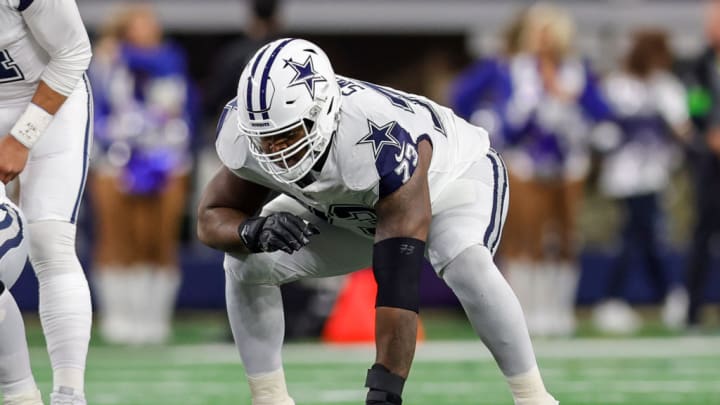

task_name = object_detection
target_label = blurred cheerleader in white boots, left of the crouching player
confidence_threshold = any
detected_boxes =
[90,5,191,344]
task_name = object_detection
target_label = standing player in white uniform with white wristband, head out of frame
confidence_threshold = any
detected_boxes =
[0,0,92,405]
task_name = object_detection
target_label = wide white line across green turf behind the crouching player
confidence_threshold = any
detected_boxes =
[31,337,720,368]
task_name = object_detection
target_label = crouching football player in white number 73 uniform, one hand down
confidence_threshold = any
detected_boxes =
[198,38,557,405]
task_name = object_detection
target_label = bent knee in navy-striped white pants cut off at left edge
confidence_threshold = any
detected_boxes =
[0,182,28,289]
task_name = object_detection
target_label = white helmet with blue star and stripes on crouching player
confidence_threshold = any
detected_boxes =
[237,38,340,183]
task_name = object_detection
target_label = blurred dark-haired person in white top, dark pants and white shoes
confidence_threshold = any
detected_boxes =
[593,30,691,333]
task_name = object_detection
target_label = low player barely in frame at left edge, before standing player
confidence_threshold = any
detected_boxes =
[0,182,43,405]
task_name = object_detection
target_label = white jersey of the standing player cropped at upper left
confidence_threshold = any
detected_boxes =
[0,0,90,107]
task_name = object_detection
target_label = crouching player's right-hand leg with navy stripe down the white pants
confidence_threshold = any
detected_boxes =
[428,150,557,405]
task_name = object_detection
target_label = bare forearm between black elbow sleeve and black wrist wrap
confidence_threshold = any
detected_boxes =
[375,307,418,378]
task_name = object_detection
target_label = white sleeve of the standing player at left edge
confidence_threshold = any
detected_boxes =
[10,0,92,96]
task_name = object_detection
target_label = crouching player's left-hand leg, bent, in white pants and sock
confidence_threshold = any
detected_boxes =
[224,196,372,405]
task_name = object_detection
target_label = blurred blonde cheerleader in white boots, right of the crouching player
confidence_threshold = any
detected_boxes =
[502,3,611,336]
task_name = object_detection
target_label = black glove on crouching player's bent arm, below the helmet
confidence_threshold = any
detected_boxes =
[238,212,320,254]
